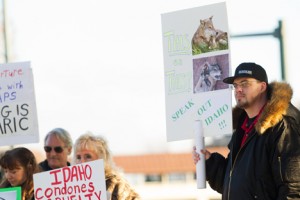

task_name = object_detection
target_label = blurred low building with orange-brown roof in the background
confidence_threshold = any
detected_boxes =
[114,147,228,200]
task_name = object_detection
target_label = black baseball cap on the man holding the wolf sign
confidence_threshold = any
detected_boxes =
[223,62,268,84]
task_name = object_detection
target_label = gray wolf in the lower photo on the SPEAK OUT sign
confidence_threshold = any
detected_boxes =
[194,62,222,93]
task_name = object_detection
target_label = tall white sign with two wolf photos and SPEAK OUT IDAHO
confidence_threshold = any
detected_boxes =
[161,2,232,141]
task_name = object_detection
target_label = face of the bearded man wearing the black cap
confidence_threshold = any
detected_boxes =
[233,78,266,109]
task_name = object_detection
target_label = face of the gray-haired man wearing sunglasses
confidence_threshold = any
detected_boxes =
[45,135,72,169]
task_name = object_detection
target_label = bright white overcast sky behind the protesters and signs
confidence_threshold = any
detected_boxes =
[1,0,300,155]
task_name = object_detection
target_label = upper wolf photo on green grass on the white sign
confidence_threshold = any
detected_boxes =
[192,16,228,55]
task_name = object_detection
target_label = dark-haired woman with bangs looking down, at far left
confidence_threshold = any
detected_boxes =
[0,147,40,200]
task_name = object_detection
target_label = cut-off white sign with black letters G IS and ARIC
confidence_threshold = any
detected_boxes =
[0,62,39,146]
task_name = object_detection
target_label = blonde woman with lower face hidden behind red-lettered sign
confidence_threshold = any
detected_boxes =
[73,132,140,200]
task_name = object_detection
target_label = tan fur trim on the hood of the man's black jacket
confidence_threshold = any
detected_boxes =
[233,82,293,134]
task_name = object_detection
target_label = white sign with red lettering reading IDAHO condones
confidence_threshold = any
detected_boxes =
[33,159,107,200]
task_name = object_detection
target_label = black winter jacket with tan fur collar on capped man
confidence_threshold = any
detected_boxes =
[206,82,300,200]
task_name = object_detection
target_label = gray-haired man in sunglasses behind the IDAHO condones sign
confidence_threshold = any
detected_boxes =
[39,128,73,171]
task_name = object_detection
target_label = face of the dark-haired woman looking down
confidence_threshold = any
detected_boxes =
[4,166,26,187]
